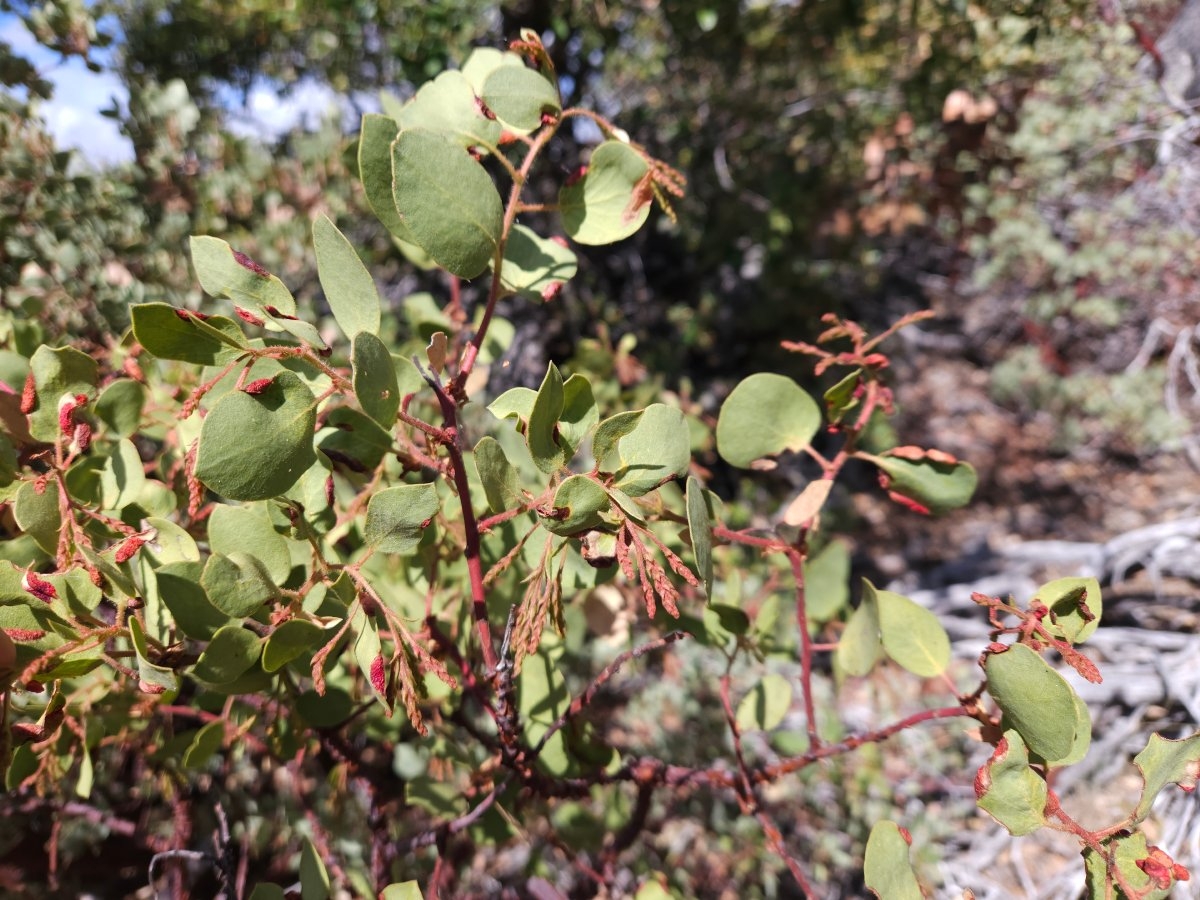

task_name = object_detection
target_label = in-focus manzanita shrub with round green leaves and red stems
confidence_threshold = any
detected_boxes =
[0,34,1200,900]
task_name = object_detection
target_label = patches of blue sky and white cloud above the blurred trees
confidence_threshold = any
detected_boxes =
[0,14,344,167]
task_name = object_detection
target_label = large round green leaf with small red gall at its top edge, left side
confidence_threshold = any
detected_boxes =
[196,372,317,500]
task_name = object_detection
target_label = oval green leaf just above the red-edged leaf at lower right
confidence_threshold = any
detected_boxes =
[984,644,1075,760]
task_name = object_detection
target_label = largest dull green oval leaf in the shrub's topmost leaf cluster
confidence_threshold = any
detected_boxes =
[391,130,504,278]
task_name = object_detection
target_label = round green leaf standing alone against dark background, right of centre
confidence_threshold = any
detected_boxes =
[716,372,821,469]
